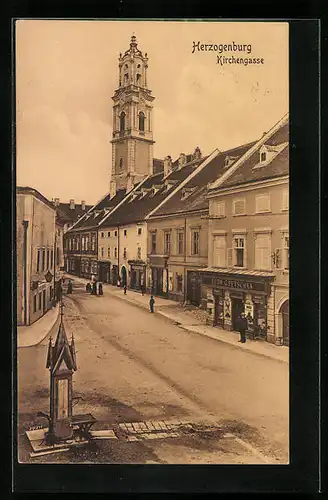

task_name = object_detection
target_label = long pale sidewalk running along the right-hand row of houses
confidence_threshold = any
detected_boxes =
[67,275,289,363]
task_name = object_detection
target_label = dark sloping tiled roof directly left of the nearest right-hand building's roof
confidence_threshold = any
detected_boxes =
[153,142,255,217]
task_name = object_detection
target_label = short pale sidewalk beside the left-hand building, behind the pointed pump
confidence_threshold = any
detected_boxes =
[17,304,59,347]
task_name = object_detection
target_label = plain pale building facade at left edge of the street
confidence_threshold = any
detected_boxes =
[16,187,57,326]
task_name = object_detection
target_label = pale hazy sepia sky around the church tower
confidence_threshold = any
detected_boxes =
[16,20,289,204]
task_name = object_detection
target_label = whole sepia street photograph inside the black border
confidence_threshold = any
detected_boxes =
[14,19,290,465]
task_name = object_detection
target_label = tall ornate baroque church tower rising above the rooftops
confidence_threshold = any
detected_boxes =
[110,35,154,194]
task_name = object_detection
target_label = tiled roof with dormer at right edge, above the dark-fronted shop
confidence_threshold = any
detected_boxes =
[218,124,289,189]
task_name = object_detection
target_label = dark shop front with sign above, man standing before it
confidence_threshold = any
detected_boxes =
[201,270,273,340]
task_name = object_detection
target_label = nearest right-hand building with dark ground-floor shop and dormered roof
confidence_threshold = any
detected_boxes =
[200,117,289,345]
